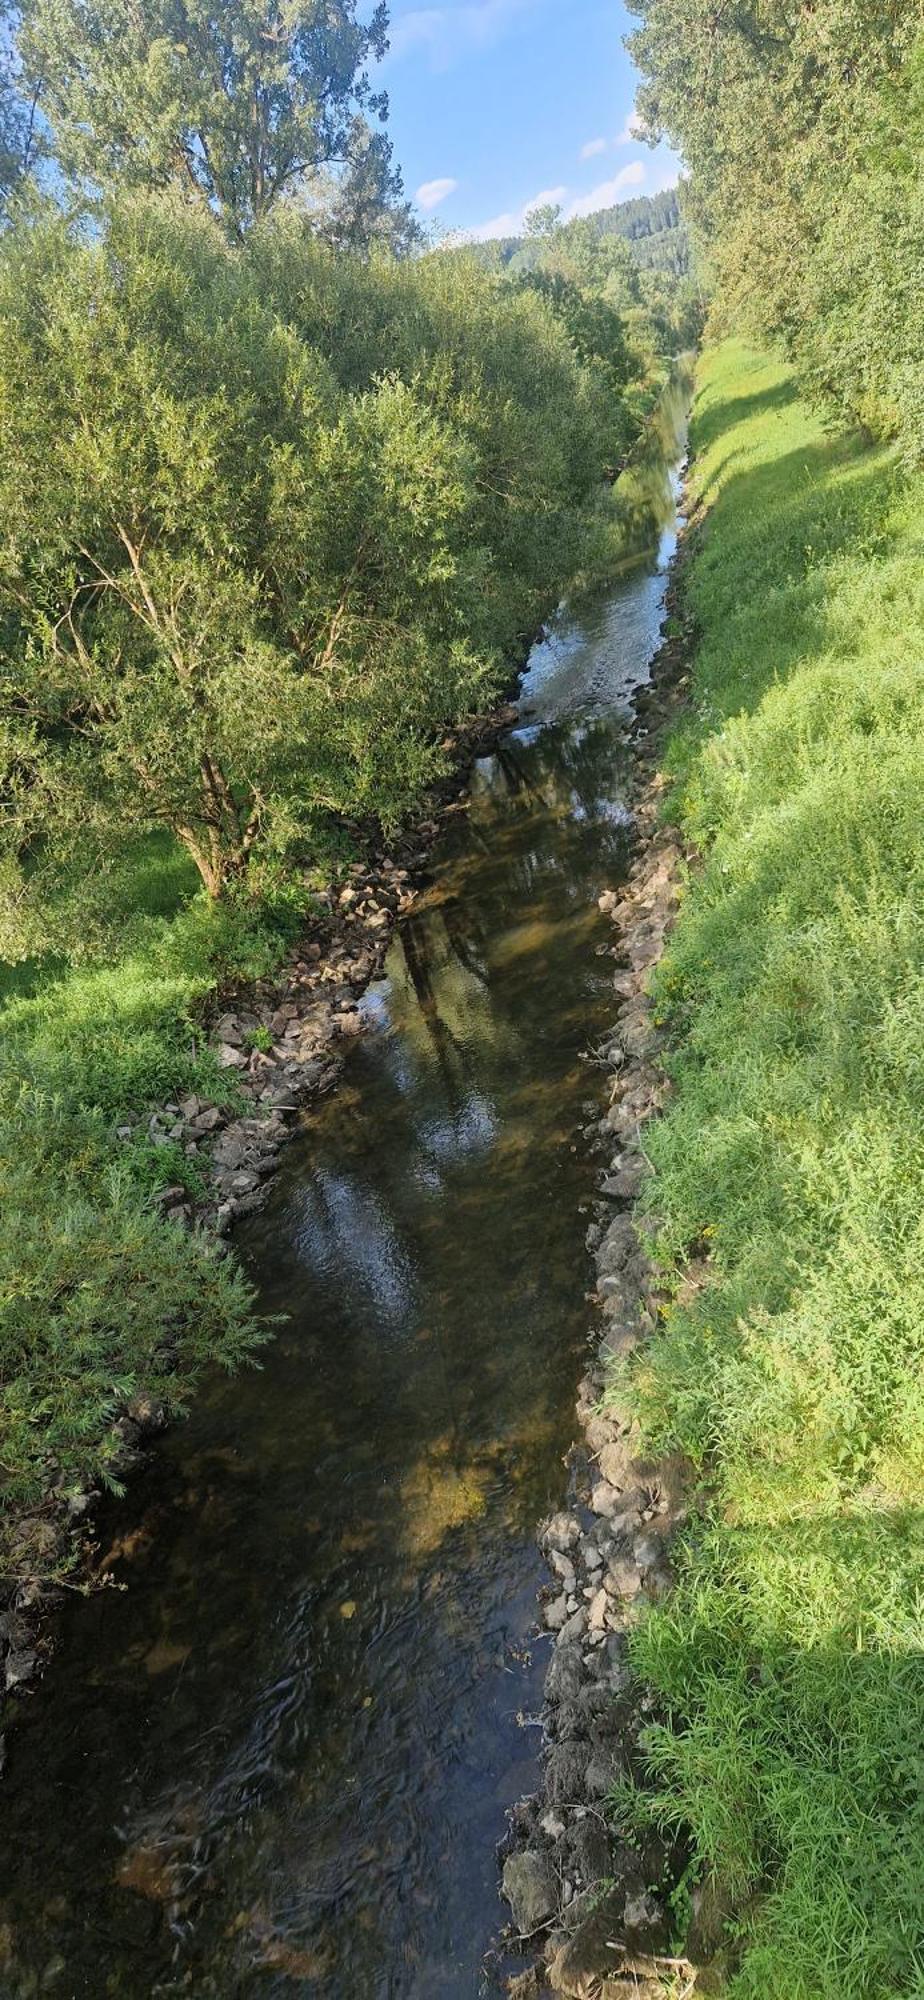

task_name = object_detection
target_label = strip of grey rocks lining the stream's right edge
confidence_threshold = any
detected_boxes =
[502,544,704,2000]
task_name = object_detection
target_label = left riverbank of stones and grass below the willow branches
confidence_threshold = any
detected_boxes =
[0,704,528,1694]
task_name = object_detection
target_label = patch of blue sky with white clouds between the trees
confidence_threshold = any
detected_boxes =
[376,0,678,236]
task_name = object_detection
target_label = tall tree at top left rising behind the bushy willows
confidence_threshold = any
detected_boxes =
[20,0,400,236]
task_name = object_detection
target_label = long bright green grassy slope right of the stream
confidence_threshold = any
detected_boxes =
[616,344,924,2000]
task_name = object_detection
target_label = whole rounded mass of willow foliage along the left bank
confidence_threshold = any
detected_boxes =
[0,200,624,958]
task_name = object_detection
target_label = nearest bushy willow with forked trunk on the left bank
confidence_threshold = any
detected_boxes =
[0,202,490,956]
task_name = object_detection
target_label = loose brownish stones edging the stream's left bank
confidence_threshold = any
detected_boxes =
[0,704,516,1704]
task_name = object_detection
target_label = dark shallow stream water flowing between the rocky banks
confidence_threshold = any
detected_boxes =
[0,378,684,2000]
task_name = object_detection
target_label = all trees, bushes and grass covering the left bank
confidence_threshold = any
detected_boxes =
[0,0,680,1554]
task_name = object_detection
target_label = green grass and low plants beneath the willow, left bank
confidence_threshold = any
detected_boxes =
[0,838,314,1536]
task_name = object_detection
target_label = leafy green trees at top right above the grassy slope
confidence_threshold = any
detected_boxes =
[630,0,924,462]
